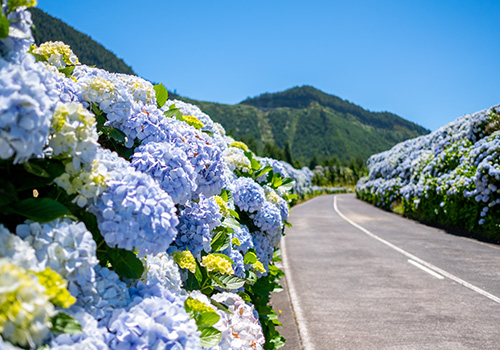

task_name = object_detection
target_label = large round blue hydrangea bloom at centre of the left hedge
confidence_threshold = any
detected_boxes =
[89,150,179,256]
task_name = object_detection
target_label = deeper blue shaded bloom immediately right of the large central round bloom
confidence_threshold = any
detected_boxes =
[174,196,222,256]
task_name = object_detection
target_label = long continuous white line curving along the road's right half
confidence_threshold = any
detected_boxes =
[333,196,500,304]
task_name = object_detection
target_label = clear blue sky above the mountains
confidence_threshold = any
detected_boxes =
[38,0,500,130]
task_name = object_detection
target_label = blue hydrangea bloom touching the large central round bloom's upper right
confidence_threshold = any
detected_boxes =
[132,142,197,204]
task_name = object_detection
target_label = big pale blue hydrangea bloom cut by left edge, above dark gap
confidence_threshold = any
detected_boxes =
[0,54,58,163]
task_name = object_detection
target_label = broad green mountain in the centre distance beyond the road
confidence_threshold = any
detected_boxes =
[176,86,429,164]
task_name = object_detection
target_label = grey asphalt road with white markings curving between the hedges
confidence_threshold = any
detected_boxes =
[282,195,500,350]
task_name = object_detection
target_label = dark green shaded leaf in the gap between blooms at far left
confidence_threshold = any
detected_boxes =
[10,198,77,223]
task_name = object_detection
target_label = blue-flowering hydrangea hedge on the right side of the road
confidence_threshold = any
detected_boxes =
[356,106,500,241]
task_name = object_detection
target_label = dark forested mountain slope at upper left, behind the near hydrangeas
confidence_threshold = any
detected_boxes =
[29,7,136,75]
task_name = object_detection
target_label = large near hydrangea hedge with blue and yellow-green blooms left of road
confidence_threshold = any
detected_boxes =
[0,0,312,350]
